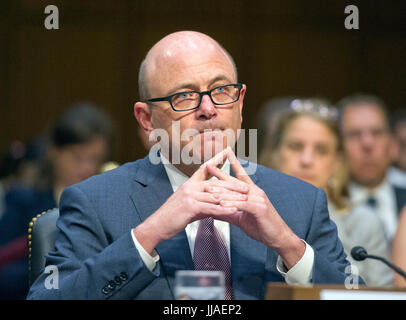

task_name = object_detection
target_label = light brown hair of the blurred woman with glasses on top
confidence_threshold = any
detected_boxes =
[259,99,348,211]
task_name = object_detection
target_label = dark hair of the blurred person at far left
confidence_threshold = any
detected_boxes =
[35,103,114,189]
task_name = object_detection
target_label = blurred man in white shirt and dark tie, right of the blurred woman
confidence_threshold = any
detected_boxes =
[339,94,406,244]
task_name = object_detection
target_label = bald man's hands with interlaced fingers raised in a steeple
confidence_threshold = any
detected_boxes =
[134,148,305,268]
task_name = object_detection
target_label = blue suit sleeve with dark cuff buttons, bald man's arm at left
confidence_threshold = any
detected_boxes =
[27,186,160,299]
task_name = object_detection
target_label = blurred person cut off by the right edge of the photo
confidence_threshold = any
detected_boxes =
[388,109,406,188]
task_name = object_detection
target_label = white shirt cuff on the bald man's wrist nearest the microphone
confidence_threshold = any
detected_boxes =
[276,240,314,285]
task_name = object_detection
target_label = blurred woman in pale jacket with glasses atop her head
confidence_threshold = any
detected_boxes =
[260,99,393,286]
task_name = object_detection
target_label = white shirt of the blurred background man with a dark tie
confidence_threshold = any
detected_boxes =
[349,179,398,243]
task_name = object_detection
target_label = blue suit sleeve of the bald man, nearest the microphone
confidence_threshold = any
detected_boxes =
[305,189,364,284]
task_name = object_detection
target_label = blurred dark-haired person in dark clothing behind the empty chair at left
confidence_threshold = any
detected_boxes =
[0,104,113,299]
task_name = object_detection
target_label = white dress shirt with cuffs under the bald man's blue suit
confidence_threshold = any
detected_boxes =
[131,154,314,284]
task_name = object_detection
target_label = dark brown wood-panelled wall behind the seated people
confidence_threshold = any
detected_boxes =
[0,0,406,162]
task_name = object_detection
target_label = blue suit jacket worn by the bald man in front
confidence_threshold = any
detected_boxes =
[28,157,349,299]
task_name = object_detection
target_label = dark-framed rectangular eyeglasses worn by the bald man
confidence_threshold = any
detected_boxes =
[147,83,242,111]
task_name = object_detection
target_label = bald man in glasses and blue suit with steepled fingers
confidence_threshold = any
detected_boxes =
[28,31,356,299]
